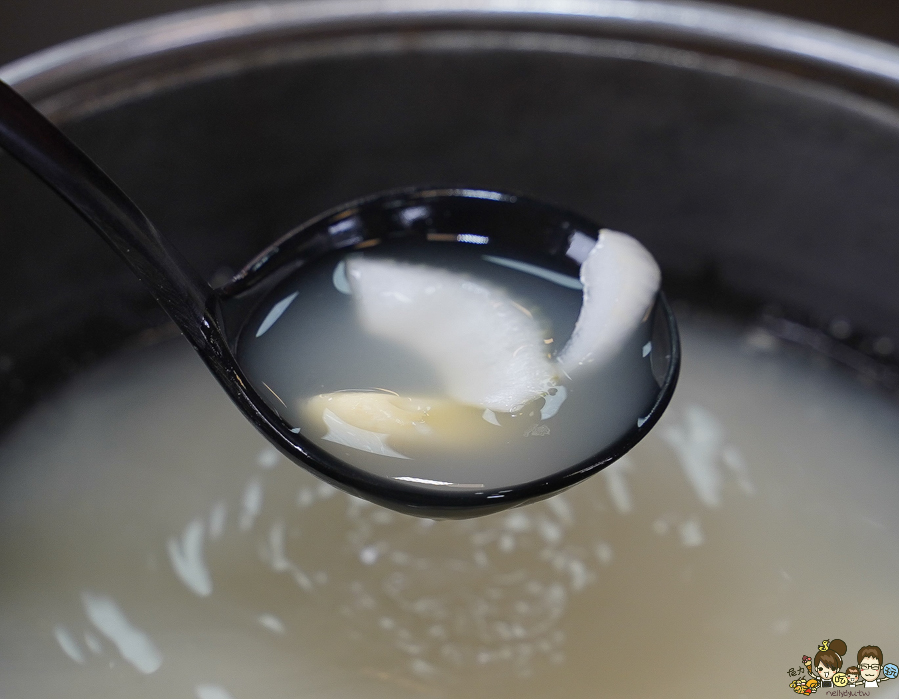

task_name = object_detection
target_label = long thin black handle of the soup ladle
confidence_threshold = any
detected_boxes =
[0,80,213,347]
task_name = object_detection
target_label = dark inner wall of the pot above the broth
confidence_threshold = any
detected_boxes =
[0,4,899,430]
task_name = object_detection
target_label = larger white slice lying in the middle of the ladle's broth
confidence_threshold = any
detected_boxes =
[346,258,557,413]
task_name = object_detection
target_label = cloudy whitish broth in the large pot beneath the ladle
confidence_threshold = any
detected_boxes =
[0,320,899,699]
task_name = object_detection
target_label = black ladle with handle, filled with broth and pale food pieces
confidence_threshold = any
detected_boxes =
[0,82,680,517]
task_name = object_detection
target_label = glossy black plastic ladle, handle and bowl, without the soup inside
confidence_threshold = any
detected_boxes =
[0,81,680,518]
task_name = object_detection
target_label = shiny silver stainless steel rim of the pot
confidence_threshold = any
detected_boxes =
[0,0,899,94]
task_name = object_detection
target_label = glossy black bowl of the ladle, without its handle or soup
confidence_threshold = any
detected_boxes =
[218,187,680,518]
